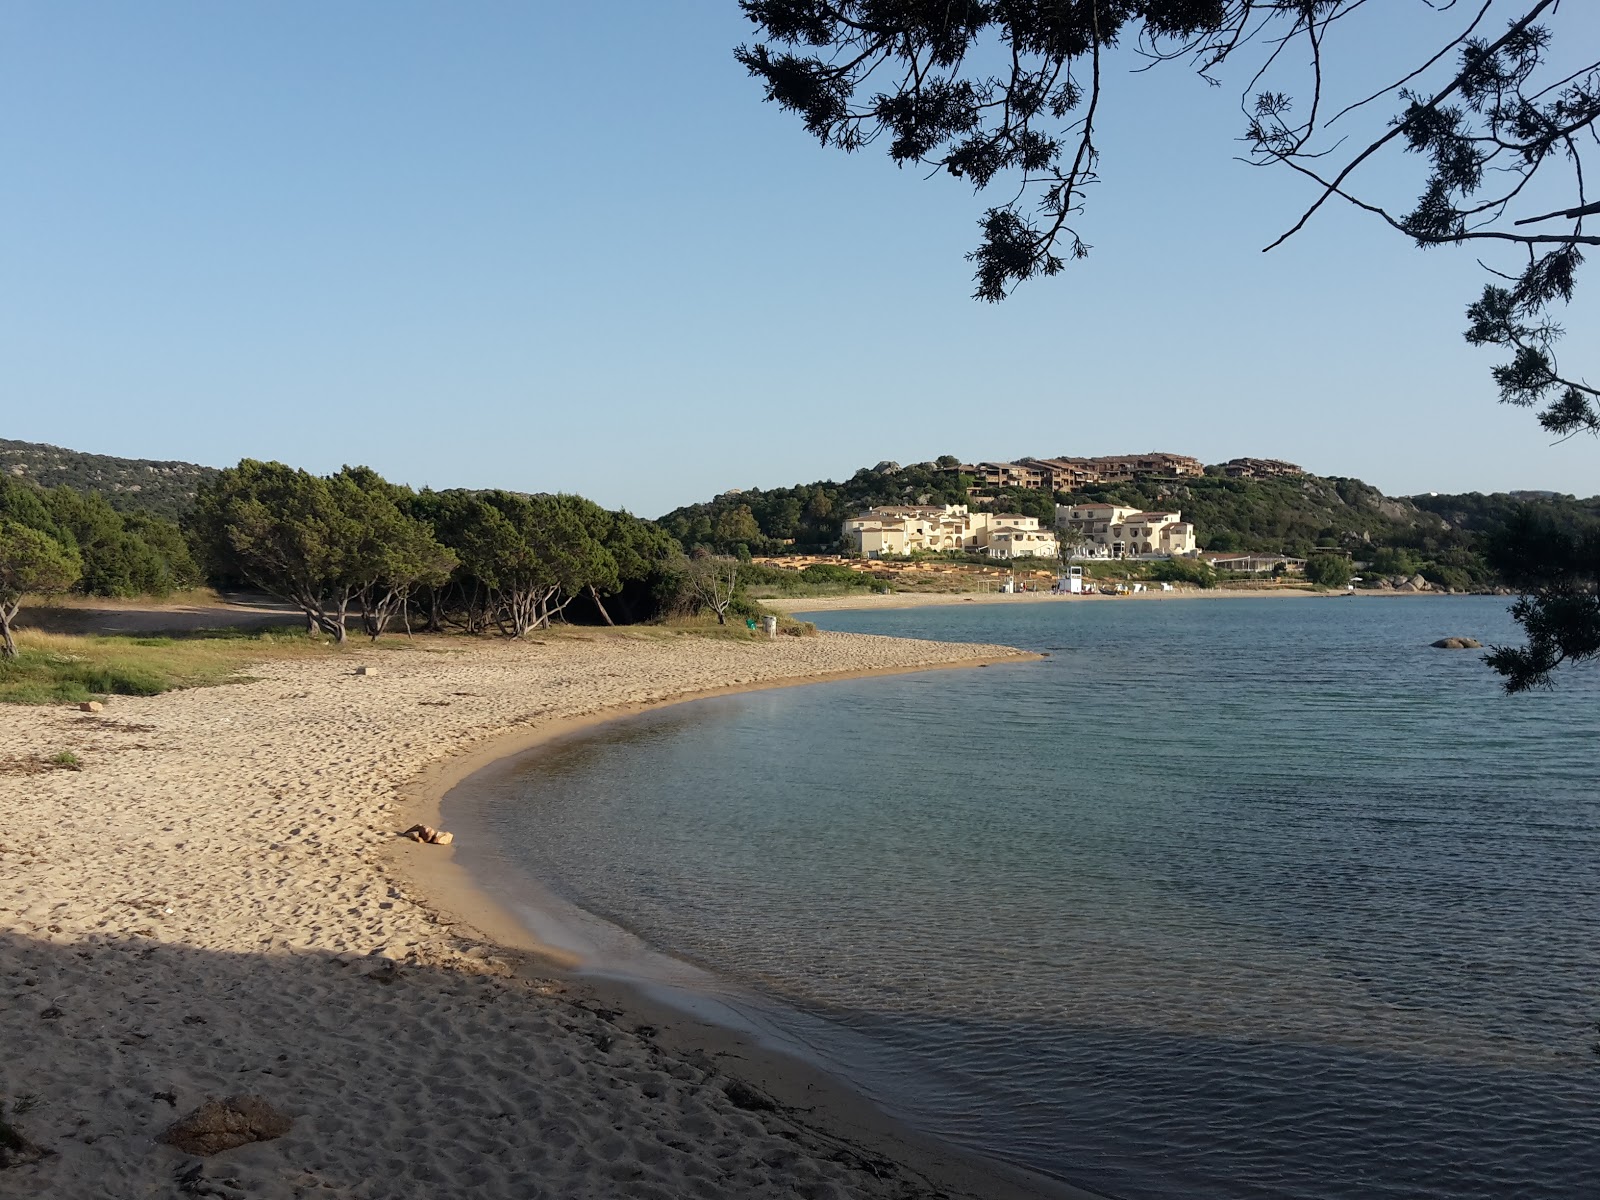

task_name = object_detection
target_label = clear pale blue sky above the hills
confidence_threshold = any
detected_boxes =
[0,0,1600,517]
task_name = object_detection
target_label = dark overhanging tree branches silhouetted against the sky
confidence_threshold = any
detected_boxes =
[734,0,1600,434]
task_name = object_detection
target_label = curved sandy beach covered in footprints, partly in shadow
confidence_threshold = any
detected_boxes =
[0,630,1100,1200]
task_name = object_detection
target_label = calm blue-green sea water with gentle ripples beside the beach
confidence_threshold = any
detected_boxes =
[448,597,1600,1200]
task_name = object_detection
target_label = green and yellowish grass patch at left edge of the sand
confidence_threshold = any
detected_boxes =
[0,630,333,704]
